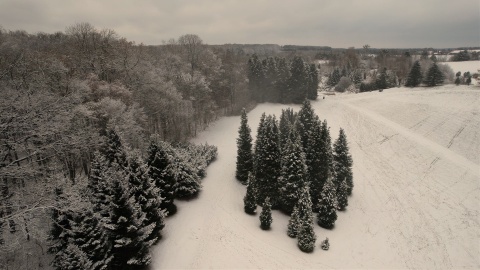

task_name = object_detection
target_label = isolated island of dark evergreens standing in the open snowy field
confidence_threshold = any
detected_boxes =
[237,100,353,252]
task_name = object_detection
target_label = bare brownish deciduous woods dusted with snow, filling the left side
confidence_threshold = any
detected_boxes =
[0,23,232,269]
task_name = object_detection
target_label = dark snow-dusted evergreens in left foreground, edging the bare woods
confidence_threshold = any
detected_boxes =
[49,130,216,270]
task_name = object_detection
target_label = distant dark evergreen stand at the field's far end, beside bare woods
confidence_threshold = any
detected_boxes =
[247,54,319,103]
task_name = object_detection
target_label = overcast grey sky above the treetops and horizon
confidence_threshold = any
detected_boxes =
[0,0,480,48]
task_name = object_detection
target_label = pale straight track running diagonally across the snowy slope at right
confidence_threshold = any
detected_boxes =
[342,102,480,177]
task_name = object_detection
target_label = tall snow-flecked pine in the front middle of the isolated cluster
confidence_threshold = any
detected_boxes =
[279,127,307,214]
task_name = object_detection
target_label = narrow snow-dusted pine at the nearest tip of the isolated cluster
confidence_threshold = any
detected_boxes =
[297,185,317,252]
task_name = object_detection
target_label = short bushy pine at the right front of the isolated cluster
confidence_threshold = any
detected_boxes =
[317,178,337,229]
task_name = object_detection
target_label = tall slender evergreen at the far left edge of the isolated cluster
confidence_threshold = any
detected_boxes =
[236,108,253,184]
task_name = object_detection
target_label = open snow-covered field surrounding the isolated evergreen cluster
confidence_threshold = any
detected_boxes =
[152,85,480,269]
